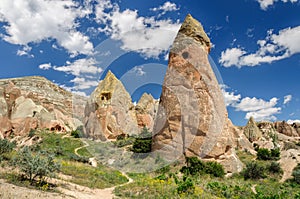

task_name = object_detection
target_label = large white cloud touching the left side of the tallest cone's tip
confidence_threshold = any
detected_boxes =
[95,1,180,58]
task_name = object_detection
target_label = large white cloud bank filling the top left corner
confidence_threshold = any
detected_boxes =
[0,0,93,56]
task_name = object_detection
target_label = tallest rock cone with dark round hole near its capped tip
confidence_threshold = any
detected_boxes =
[152,15,251,172]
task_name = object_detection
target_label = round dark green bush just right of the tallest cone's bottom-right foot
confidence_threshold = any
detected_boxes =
[242,162,266,180]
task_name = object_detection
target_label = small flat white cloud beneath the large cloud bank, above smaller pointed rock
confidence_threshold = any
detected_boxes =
[53,58,102,77]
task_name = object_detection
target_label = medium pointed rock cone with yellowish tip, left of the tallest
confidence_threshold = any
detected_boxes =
[84,71,139,141]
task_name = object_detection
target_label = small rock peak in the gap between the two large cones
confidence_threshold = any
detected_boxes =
[135,93,158,132]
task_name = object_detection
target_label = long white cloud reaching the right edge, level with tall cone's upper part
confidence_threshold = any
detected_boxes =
[219,26,300,67]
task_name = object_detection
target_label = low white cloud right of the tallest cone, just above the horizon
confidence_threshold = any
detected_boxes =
[221,86,281,121]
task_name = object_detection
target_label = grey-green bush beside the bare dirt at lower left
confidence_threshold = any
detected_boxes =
[14,147,60,183]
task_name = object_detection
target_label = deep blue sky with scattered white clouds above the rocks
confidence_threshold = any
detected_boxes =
[0,0,300,125]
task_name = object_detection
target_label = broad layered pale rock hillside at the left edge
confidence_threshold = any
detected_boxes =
[0,76,85,137]
